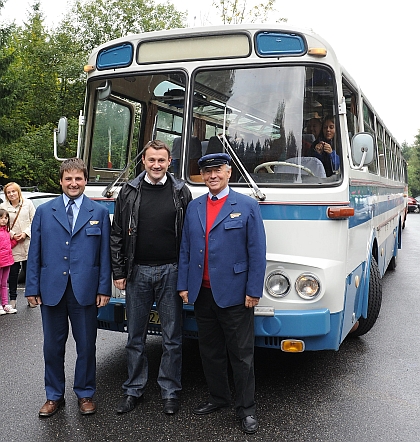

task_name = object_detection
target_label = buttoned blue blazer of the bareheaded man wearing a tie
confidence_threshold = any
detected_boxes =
[25,195,111,306]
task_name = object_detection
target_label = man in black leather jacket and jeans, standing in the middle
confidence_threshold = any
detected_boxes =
[111,140,191,414]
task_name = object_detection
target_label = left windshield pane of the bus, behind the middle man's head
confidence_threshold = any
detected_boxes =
[85,71,186,182]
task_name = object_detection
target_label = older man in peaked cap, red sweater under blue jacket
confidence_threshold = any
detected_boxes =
[177,153,266,433]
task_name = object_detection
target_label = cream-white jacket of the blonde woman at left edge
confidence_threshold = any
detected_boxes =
[1,198,35,262]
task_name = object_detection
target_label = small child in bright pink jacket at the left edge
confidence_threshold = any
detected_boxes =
[0,209,17,315]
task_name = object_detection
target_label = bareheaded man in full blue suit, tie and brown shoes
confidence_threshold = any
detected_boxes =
[25,158,111,417]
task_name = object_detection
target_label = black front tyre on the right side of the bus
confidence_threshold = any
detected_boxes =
[349,256,382,338]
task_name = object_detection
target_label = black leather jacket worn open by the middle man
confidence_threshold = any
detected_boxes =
[111,171,192,280]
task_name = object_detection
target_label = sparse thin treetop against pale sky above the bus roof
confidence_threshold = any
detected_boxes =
[213,0,287,25]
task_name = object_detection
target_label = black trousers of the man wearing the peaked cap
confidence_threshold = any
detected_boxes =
[194,287,255,419]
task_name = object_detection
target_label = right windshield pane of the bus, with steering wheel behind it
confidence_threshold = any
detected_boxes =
[193,66,341,185]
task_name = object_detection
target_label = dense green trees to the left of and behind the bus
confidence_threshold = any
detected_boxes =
[0,0,186,185]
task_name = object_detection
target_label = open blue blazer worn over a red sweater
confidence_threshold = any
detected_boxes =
[177,189,266,308]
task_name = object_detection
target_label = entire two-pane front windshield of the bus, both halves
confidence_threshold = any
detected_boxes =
[88,65,342,186]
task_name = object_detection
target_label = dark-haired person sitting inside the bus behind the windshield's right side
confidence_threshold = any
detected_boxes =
[308,116,340,177]
